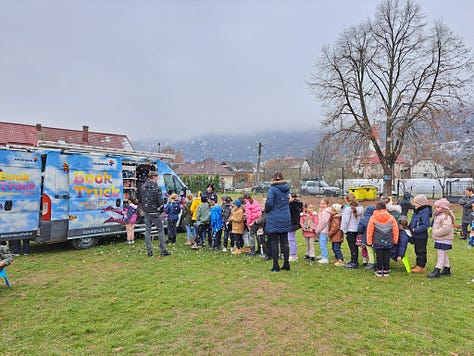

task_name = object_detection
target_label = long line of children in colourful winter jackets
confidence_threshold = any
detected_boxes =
[177,187,466,278]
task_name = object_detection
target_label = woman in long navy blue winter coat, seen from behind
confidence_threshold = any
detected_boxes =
[265,172,291,272]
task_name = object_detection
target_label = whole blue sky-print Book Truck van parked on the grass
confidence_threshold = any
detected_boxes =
[0,142,186,249]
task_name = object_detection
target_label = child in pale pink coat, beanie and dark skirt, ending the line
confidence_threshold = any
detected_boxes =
[428,198,456,278]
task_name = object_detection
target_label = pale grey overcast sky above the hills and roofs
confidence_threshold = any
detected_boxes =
[0,0,474,141]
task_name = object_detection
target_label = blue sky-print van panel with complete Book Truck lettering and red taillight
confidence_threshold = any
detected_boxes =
[41,152,123,242]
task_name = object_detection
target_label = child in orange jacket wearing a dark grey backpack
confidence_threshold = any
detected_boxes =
[367,201,399,277]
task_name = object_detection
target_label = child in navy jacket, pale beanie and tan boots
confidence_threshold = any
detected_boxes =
[408,194,432,273]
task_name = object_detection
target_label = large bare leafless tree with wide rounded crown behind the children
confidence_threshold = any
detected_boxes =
[309,0,474,192]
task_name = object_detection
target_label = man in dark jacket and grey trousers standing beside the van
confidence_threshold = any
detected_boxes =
[140,171,171,257]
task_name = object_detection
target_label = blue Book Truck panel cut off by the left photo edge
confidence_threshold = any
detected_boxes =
[0,150,41,240]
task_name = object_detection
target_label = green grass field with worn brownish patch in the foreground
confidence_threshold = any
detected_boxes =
[0,210,474,355]
